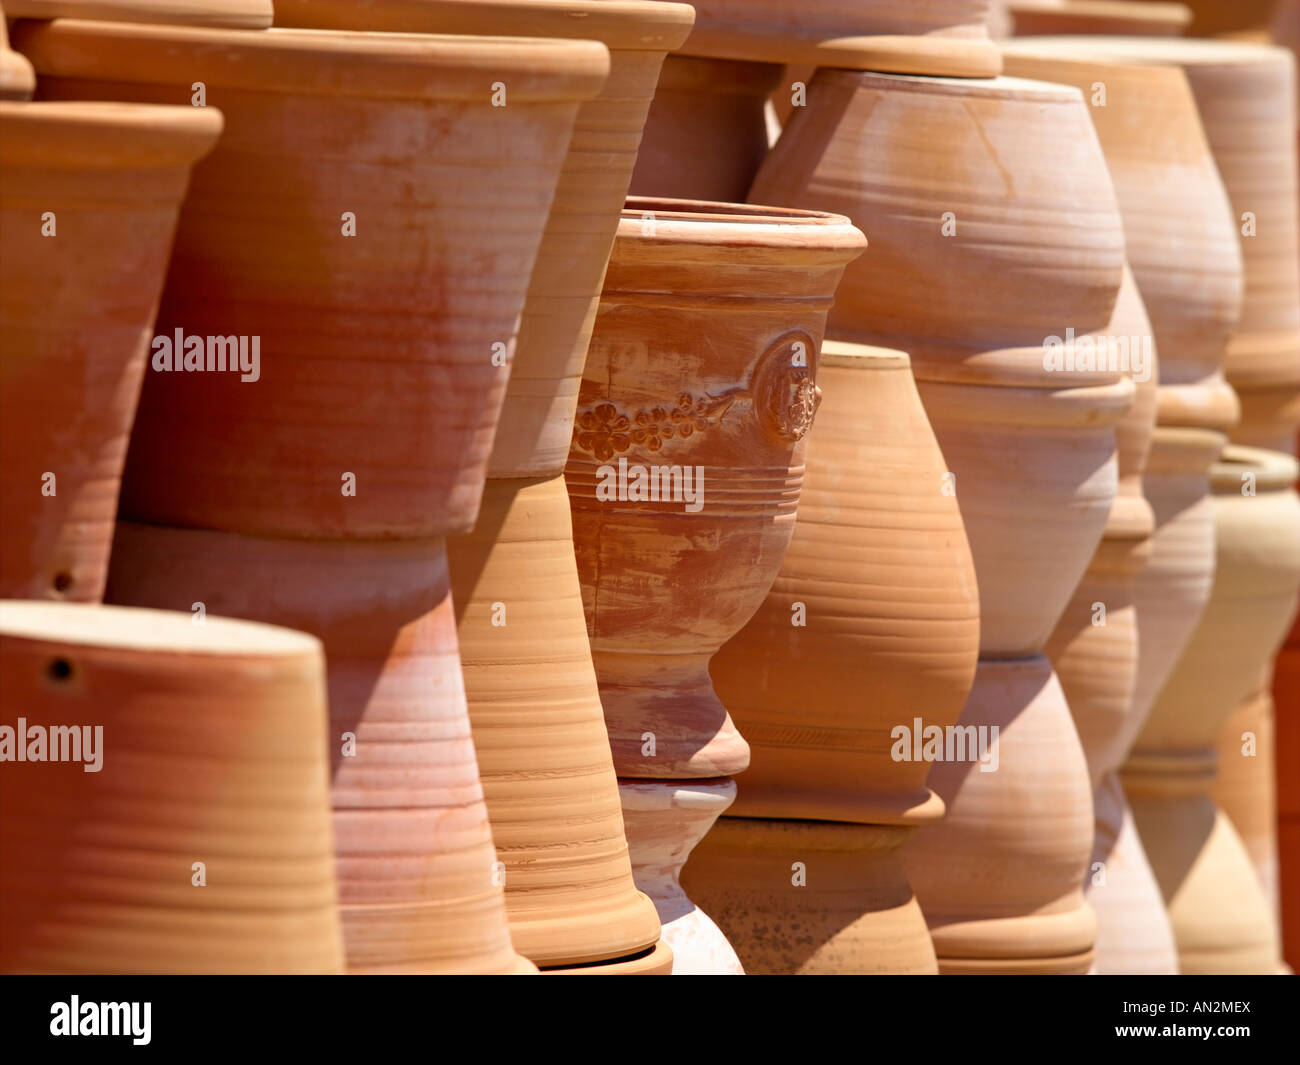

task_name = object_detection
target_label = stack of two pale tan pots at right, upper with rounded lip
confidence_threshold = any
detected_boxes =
[1125,446,1300,973]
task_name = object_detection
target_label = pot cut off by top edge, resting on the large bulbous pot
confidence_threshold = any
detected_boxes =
[683,0,1001,78]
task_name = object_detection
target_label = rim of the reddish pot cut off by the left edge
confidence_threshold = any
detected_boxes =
[0,100,225,170]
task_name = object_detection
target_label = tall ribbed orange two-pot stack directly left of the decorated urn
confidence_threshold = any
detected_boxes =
[276,0,693,971]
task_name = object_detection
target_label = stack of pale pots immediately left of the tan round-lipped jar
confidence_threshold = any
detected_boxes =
[1004,38,1242,973]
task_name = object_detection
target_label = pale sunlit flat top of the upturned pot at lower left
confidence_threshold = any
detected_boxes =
[0,599,325,662]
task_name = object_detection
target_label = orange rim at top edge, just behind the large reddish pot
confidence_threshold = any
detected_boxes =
[276,0,696,52]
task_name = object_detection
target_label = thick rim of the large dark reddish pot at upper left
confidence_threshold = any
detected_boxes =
[13,18,610,100]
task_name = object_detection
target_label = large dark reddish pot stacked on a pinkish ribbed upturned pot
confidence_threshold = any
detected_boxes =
[16,21,608,973]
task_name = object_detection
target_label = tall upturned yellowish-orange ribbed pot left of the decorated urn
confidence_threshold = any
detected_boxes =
[449,476,659,965]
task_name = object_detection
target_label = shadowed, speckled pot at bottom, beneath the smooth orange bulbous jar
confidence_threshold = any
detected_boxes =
[681,817,935,975]
